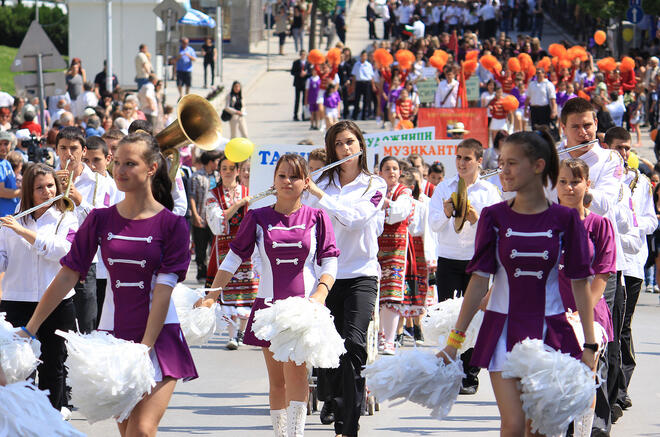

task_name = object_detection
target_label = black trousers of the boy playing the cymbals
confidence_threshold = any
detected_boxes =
[435,257,481,387]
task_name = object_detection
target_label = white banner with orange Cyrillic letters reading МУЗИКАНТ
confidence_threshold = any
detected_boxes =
[382,140,461,178]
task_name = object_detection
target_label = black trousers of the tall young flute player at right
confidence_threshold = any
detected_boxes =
[593,271,626,432]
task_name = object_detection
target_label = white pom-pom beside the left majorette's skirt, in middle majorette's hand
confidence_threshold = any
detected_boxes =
[172,284,218,346]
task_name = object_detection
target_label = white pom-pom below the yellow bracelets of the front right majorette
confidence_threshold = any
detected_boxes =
[362,349,465,419]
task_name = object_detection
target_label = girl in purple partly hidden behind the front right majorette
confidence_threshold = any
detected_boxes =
[557,159,616,437]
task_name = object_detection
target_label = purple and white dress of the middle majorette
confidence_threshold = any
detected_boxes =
[220,205,339,347]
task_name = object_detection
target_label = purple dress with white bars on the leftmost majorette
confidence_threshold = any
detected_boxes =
[60,206,197,381]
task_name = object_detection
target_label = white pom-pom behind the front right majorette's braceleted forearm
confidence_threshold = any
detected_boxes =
[422,297,484,352]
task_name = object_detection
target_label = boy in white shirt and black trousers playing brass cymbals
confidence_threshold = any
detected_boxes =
[429,139,502,394]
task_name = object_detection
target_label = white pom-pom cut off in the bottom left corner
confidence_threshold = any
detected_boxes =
[0,381,85,437]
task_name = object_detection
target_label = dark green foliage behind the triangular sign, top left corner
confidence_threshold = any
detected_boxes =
[0,3,69,55]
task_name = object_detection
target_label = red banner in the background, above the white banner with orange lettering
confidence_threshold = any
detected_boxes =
[417,108,488,147]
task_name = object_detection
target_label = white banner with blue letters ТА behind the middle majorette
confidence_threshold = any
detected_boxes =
[250,144,319,209]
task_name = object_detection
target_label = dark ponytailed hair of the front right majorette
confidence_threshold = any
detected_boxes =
[504,128,559,188]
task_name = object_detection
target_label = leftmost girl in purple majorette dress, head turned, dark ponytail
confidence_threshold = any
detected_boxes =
[20,133,197,436]
